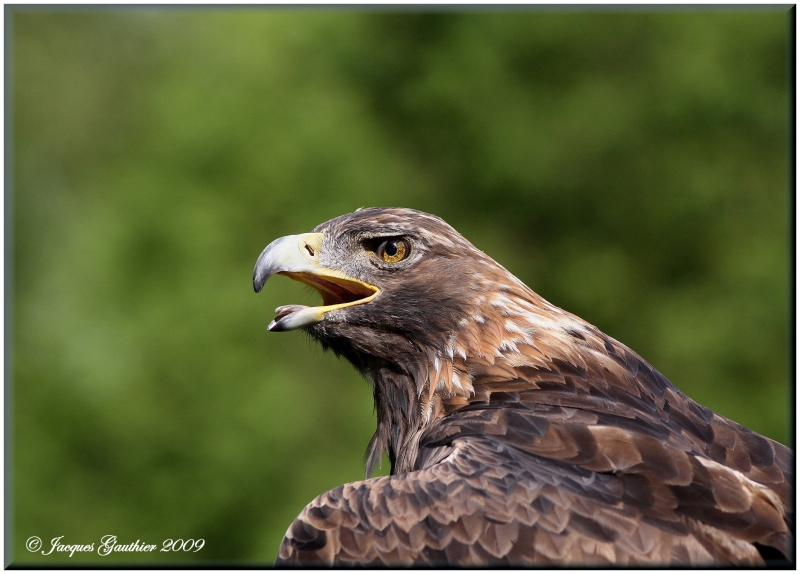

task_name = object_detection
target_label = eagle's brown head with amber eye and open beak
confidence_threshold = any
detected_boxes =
[253,208,527,368]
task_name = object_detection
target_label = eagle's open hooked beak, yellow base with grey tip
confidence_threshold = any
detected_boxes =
[253,233,380,331]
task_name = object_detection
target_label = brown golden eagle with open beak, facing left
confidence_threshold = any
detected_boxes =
[253,208,794,566]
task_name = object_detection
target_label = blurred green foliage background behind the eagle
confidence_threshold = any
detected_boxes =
[5,6,794,565]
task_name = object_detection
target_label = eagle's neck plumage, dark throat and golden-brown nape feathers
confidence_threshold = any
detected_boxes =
[314,274,619,476]
